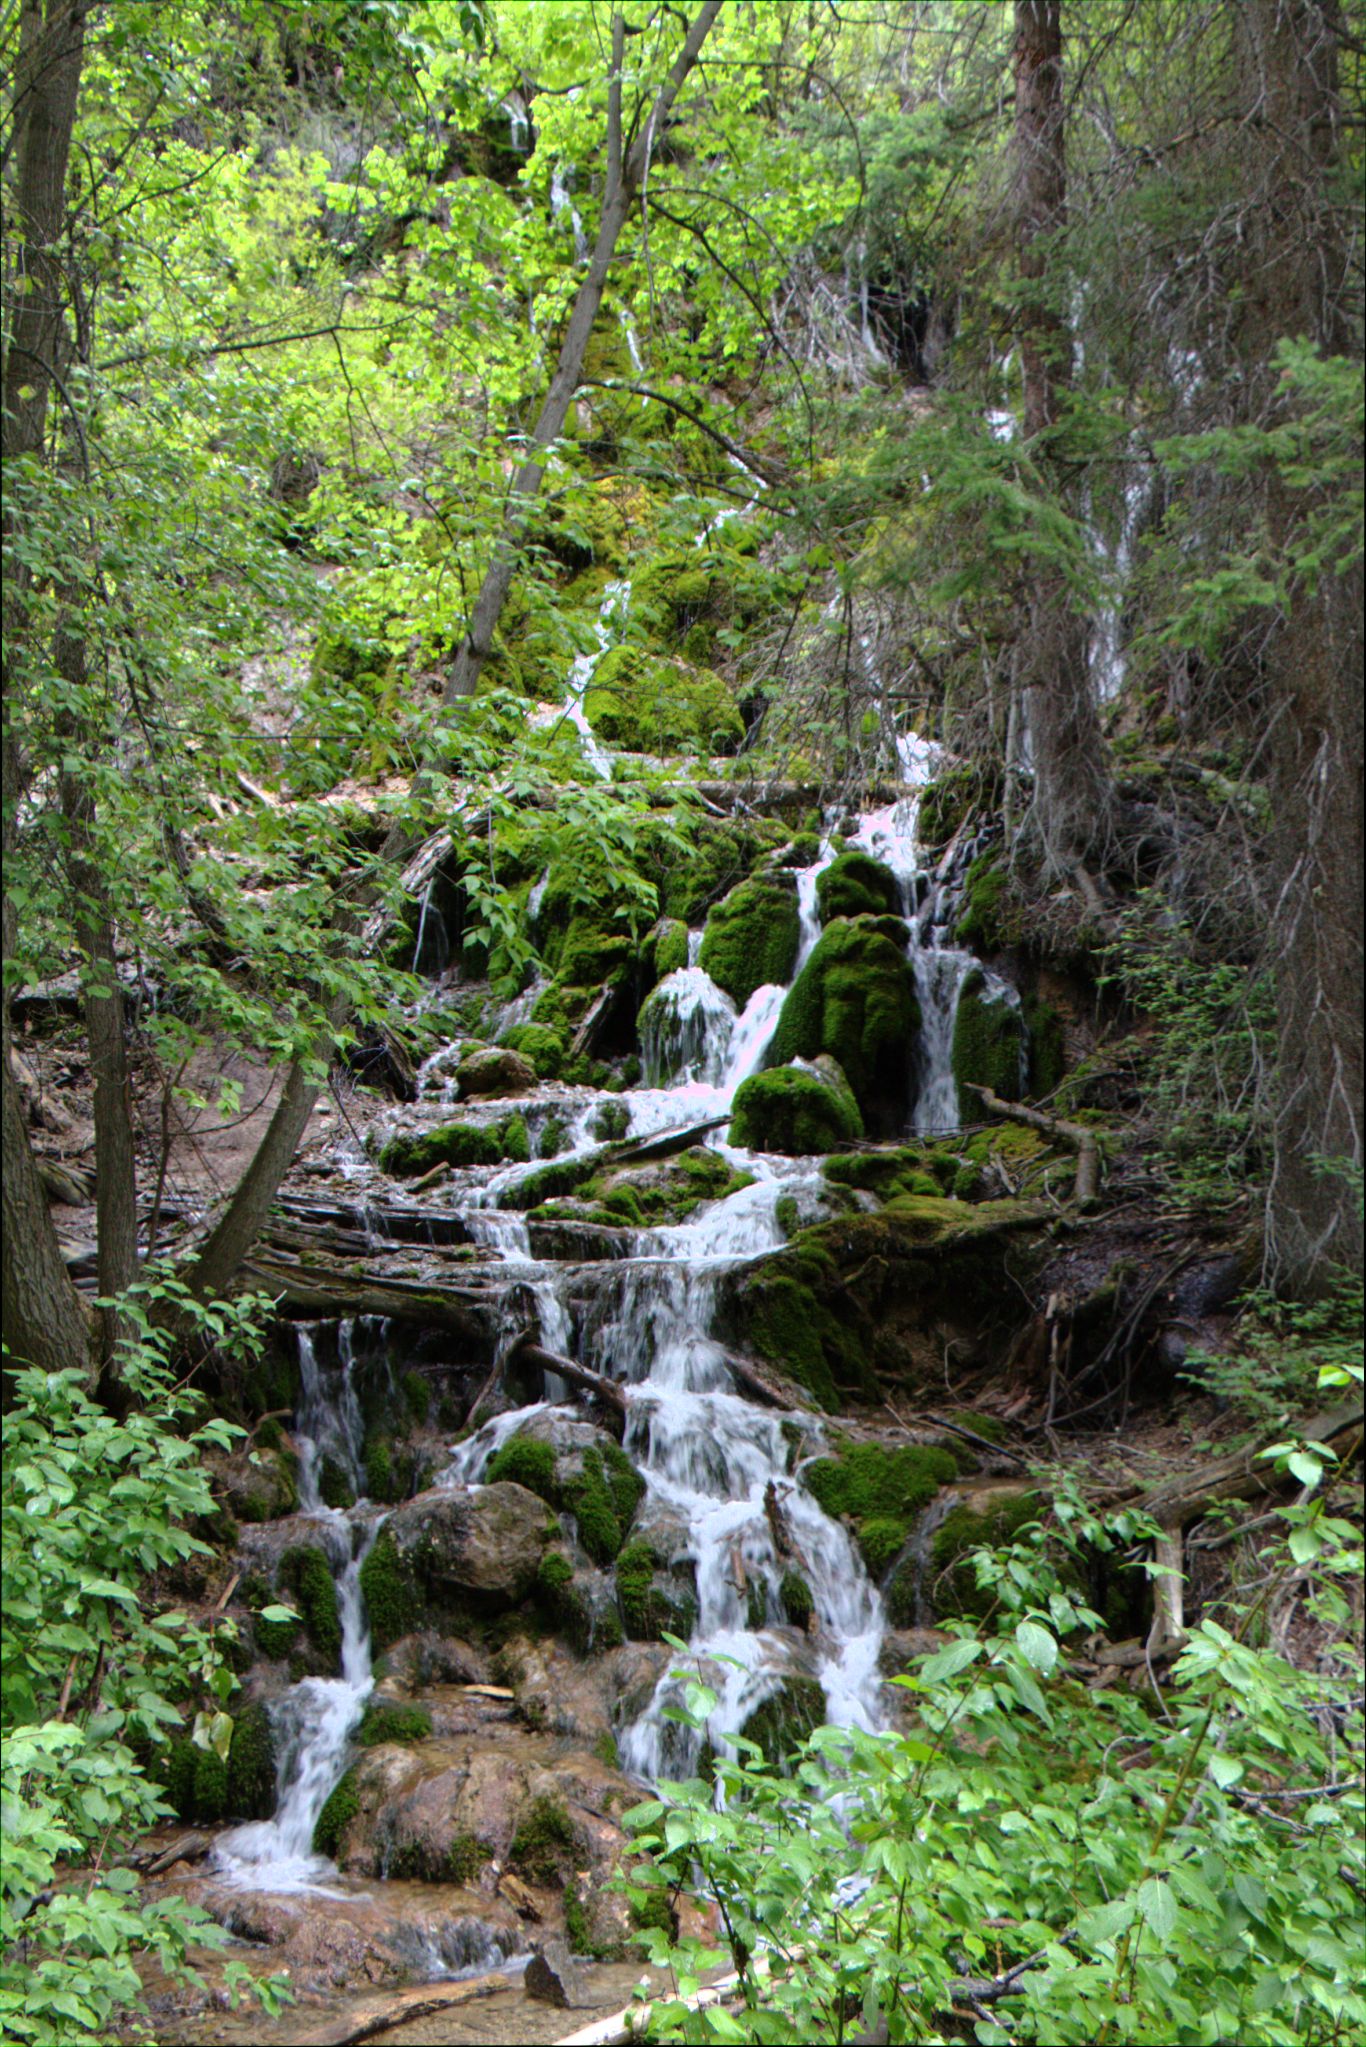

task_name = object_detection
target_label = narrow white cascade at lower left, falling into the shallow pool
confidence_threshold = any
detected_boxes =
[215,1322,383,1891]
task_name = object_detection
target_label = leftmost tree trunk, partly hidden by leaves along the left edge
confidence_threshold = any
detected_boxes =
[0,0,94,1371]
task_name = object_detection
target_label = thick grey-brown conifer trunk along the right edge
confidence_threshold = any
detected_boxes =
[1233,0,1364,1294]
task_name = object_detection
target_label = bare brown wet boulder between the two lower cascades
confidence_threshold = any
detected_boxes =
[385,1482,557,1613]
